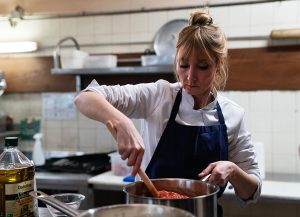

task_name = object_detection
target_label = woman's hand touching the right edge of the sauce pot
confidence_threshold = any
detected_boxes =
[198,161,236,187]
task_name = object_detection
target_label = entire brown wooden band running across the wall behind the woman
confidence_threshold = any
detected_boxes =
[0,45,300,93]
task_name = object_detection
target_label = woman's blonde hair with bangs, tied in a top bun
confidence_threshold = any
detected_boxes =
[174,10,228,90]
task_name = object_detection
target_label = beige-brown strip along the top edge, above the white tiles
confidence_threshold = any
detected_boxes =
[0,0,268,16]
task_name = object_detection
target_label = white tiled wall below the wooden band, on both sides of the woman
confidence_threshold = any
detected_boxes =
[0,90,300,174]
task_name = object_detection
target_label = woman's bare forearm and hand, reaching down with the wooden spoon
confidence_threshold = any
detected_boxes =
[75,92,144,175]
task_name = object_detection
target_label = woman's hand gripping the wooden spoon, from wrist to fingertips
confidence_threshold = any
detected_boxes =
[114,117,145,176]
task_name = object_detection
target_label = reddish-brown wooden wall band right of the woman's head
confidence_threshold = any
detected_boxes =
[226,46,300,90]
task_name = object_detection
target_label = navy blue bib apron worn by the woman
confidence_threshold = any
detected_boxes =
[146,90,228,216]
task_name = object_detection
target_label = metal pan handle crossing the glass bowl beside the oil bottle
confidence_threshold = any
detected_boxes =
[29,191,81,217]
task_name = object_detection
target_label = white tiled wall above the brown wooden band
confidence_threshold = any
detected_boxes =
[0,0,300,55]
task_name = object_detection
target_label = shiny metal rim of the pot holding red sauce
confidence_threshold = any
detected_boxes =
[123,178,220,200]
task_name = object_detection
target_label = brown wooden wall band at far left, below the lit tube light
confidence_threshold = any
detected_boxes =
[0,57,75,93]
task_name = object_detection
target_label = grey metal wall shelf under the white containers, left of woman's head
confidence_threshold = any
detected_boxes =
[51,65,173,75]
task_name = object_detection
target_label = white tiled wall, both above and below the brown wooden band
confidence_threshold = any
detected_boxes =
[0,1,300,173]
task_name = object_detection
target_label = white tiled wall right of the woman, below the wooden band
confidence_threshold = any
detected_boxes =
[220,91,300,173]
